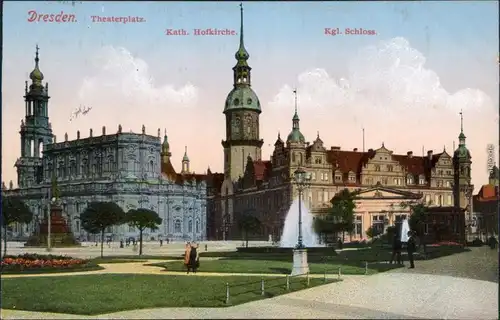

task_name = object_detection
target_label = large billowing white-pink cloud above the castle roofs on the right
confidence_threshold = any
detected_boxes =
[270,37,498,190]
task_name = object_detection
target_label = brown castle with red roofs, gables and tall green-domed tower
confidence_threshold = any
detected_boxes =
[203,8,473,240]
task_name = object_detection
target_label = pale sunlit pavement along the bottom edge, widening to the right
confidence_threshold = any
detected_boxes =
[1,272,498,319]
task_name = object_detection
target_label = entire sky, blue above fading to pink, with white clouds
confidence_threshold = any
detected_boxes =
[2,1,499,190]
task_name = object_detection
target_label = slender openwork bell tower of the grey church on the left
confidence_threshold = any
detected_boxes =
[15,46,53,188]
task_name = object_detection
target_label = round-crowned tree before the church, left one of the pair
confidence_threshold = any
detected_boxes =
[80,202,125,258]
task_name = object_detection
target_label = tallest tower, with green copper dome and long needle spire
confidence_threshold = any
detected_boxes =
[222,4,264,181]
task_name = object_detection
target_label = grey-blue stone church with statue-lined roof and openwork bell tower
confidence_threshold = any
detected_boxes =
[2,46,207,241]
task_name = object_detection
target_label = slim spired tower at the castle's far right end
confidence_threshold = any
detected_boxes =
[453,112,474,219]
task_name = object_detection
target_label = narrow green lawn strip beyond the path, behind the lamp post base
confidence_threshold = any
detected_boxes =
[151,258,397,274]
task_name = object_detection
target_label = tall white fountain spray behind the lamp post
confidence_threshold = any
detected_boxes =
[280,199,320,248]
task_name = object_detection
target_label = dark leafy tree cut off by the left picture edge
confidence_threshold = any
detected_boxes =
[0,197,33,255]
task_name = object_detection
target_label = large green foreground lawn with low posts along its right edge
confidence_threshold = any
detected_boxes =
[1,274,332,315]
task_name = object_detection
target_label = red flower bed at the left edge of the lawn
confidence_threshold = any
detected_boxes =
[1,254,100,273]
